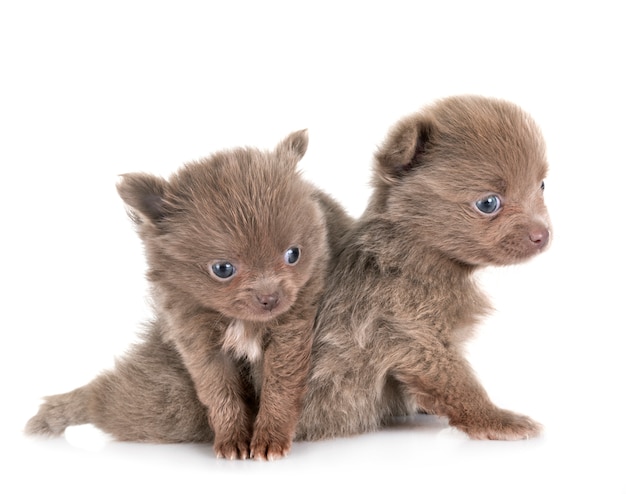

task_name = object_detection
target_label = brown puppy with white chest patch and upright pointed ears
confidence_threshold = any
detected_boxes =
[26,131,350,459]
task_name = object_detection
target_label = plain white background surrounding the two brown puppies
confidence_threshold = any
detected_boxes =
[0,0,626,493]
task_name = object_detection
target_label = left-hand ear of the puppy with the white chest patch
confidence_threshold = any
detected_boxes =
[117,173,171,224]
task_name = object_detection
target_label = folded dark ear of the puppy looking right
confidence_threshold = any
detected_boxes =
[375,114,435,183]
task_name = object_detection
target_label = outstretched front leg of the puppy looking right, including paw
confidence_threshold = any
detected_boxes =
[395,344,541,440]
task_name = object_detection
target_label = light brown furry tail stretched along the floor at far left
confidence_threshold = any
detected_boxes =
[24,386,89,436]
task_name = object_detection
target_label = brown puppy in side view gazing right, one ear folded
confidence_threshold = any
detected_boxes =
[297,96,550,440]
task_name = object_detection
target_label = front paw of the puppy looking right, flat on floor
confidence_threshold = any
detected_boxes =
[450,409,542,441]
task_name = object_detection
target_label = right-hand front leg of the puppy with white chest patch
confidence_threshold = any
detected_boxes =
[250,311,315,460]
